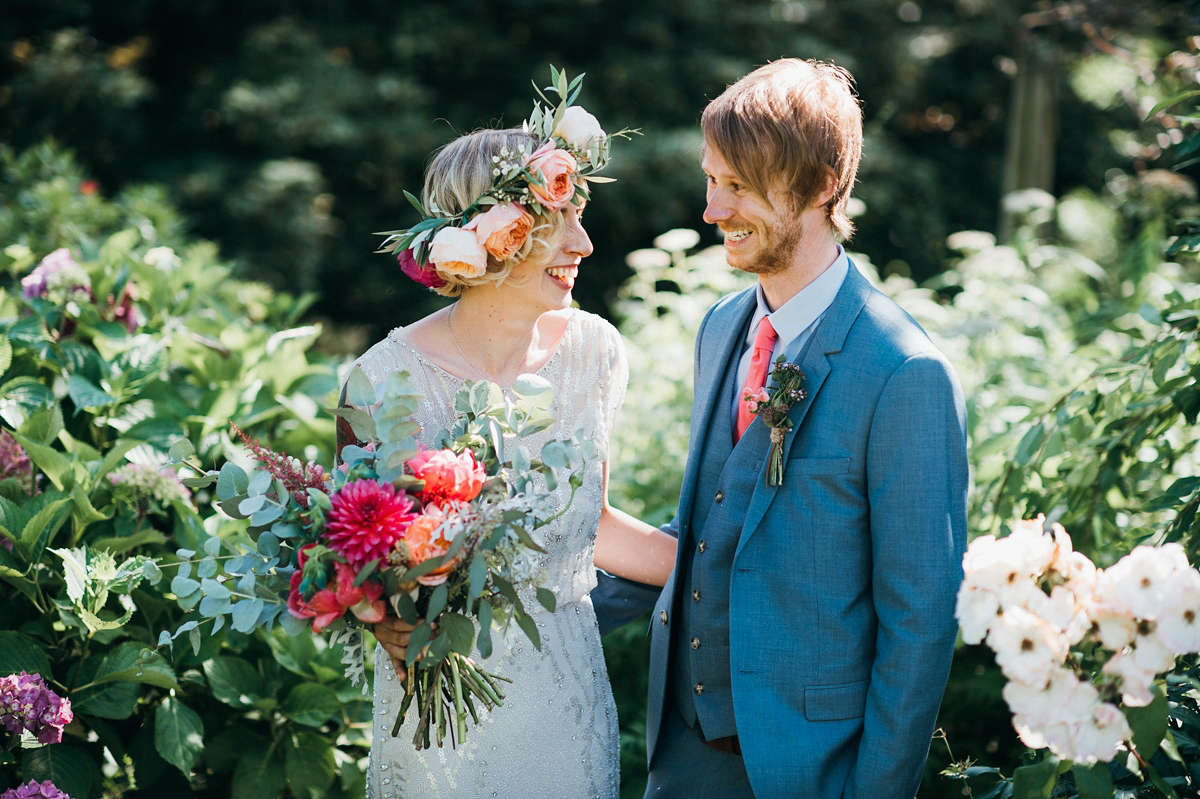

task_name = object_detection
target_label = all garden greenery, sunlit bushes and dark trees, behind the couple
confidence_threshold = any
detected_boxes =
[0,0,1200,799]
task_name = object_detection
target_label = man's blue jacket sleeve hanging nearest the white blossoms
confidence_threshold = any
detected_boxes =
[846,354,968,799]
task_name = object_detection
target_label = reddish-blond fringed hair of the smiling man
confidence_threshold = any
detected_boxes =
[700,59,863,239]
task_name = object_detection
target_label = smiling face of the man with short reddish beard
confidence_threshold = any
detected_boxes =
[700,144,804,275]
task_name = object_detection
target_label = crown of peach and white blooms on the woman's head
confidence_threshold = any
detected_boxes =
[378,66,637,288]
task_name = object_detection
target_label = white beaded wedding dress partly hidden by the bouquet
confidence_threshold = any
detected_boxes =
[358,311,628,799]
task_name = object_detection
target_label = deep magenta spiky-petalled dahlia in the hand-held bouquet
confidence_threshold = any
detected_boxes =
[325,480,416,571]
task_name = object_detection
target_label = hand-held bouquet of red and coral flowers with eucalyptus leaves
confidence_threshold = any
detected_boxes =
[169,370,593,749]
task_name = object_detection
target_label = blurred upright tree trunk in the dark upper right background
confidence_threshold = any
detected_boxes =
[1000,31,1058,241]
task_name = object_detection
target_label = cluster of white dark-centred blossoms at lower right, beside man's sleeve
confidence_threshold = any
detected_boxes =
[955,515,1200,797]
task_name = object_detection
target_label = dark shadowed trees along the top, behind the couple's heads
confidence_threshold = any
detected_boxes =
[0,0,1200,350]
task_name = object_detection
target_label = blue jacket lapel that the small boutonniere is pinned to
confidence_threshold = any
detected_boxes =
[734,262,874,557]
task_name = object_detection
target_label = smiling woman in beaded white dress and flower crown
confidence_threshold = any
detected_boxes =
[340,78,676,799]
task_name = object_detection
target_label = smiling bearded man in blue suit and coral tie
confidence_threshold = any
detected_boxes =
[600,59,967,799]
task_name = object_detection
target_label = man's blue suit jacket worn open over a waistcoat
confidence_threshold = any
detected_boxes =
[647,266,967,799]
